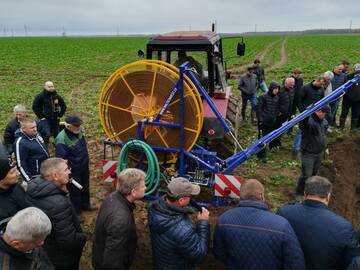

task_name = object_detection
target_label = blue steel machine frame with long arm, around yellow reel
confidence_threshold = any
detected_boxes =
[103,62,360,176]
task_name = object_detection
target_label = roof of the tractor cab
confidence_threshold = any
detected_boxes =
[148,31,220,45]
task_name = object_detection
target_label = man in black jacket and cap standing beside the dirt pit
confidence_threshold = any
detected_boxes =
[296,105,331,202]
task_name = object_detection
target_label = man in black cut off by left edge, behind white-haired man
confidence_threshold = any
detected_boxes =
[0,159,28,223]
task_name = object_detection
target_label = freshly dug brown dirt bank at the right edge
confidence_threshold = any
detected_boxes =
[320,134,360,230]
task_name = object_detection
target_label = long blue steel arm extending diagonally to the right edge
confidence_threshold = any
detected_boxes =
[222,76,360,174]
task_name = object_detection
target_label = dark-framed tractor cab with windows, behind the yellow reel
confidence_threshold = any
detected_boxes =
[146,31,244,99]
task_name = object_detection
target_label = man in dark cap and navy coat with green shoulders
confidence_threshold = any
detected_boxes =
[55,115,90,215]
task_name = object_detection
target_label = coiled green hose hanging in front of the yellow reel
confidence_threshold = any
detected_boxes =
[118,140,160,195]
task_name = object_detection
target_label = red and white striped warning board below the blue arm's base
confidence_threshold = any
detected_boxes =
[215,174,244,199]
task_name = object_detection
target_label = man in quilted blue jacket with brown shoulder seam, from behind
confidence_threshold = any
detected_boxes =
[214,179,305,270]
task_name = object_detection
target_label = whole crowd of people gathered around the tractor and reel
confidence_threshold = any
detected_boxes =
[0,60,360,270]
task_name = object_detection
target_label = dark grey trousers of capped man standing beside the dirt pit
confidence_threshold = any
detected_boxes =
[296,152,324,196]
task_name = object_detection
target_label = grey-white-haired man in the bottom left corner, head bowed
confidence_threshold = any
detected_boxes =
[0,207,54,270]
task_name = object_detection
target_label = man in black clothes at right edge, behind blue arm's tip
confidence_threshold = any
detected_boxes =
[340,64,360,129]
